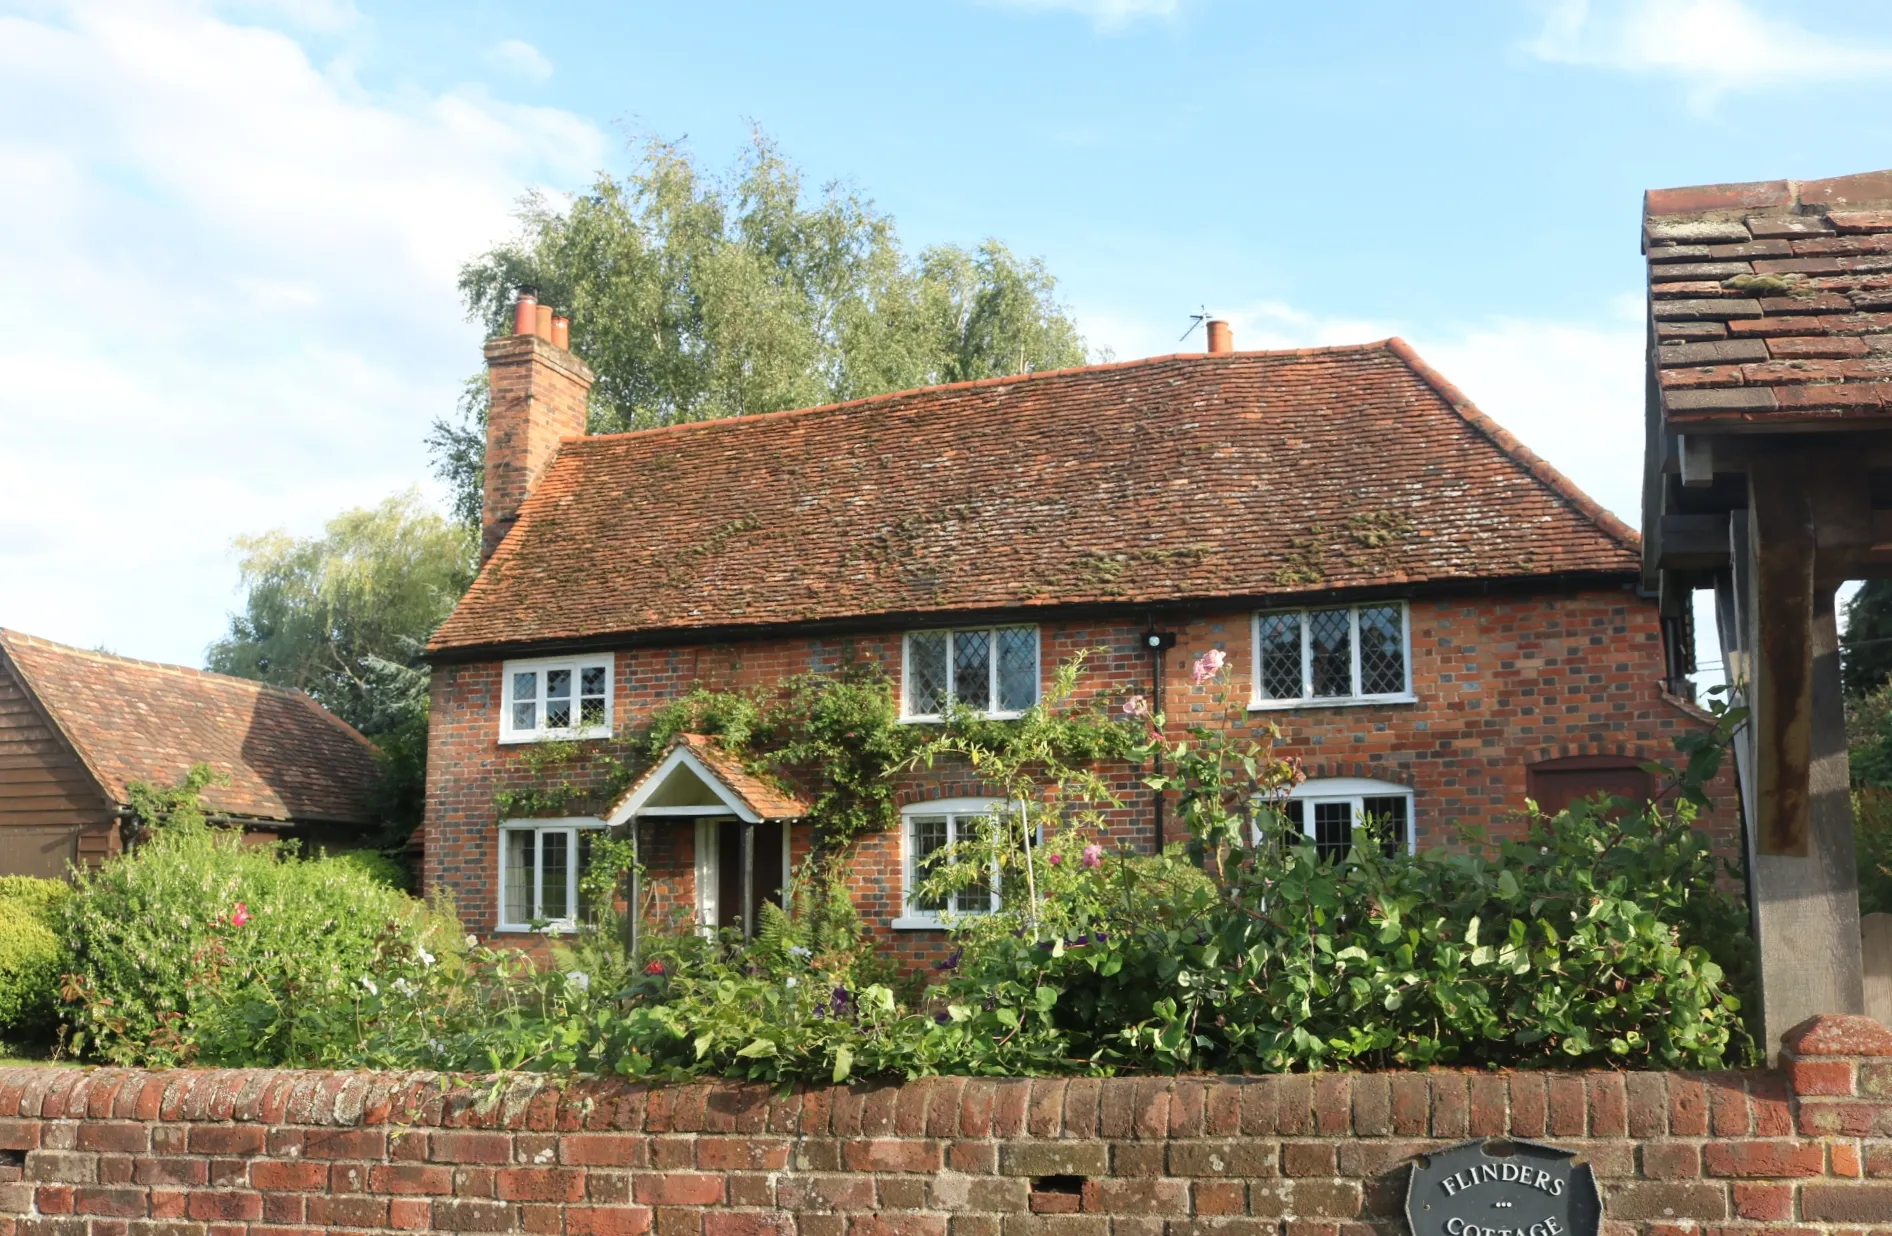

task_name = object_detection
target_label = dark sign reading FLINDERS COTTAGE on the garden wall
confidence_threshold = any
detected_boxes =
[1406,1139,1603,1236]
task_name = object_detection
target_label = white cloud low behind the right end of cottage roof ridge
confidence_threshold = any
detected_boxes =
[1078,301,1642,526]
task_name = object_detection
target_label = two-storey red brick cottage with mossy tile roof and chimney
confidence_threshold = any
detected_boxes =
[426,305,1735,962]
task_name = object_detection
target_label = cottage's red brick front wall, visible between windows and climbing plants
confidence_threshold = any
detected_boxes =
[426,589,1737,965]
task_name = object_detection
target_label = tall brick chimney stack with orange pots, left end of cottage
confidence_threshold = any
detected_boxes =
[479,293,594,562]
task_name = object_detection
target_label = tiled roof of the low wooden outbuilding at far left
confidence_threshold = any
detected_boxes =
[0,628,375,823]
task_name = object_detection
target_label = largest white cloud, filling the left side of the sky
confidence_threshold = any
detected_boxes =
[0,0,607,662]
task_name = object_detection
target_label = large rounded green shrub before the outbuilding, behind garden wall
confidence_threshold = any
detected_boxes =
[64,823,458,1066]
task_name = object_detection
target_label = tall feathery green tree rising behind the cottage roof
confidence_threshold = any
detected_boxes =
[429,134,1088,521]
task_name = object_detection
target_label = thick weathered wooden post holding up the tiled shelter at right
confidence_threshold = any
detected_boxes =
[1718,450,1866,1060]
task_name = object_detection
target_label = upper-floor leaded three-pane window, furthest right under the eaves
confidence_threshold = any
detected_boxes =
[1249,602,1413,708]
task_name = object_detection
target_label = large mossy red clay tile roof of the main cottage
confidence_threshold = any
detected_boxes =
[431,339,1638,653]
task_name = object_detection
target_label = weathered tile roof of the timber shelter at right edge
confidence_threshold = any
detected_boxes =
[1642,172,1892,430]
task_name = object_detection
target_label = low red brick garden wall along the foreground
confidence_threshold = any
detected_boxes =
[0,1018,1892,1236]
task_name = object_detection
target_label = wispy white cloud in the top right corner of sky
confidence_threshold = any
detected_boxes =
[1527,0,1892,106]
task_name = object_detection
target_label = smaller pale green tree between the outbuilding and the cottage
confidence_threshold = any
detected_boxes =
[206,490,477,825]
